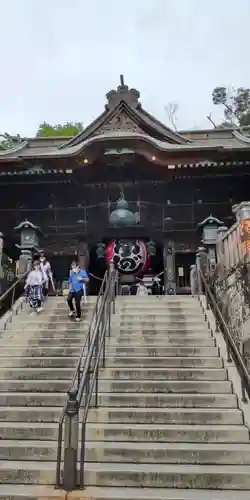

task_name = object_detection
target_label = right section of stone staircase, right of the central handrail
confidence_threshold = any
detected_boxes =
[80,296,250,500]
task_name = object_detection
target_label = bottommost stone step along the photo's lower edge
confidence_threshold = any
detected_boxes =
[0,484,249,500]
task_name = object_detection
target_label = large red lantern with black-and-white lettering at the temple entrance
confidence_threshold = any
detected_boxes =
[105,239,150,276]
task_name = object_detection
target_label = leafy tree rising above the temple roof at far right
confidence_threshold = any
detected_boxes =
[212,87,250,128]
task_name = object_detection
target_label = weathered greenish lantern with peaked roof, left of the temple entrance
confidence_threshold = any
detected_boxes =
[14,219,42,276]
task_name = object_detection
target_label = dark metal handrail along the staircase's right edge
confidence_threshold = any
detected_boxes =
[199,269,250,403]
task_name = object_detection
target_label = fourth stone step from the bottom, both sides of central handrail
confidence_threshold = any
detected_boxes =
[0,422,249,442]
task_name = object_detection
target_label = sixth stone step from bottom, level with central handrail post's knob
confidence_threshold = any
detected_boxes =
[0,391,237,408]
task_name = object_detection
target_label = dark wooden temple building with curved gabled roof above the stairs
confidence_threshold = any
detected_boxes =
[0,77,250,293]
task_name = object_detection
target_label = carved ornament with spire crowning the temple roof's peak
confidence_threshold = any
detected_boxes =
[105,75,141,111]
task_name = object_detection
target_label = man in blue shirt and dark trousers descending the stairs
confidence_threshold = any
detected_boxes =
[68,261,89,322]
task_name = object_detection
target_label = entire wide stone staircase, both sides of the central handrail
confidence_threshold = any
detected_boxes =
[0,296,250,500]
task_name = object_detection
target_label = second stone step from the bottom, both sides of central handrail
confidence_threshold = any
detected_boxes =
[0,460,250,488]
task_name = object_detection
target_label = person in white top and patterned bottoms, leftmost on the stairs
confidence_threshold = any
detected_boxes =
[24,260,44,313]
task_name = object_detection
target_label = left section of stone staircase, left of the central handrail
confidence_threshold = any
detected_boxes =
[0,297,96,500]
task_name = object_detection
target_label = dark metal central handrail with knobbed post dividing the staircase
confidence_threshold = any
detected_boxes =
[56,270,117,491]
